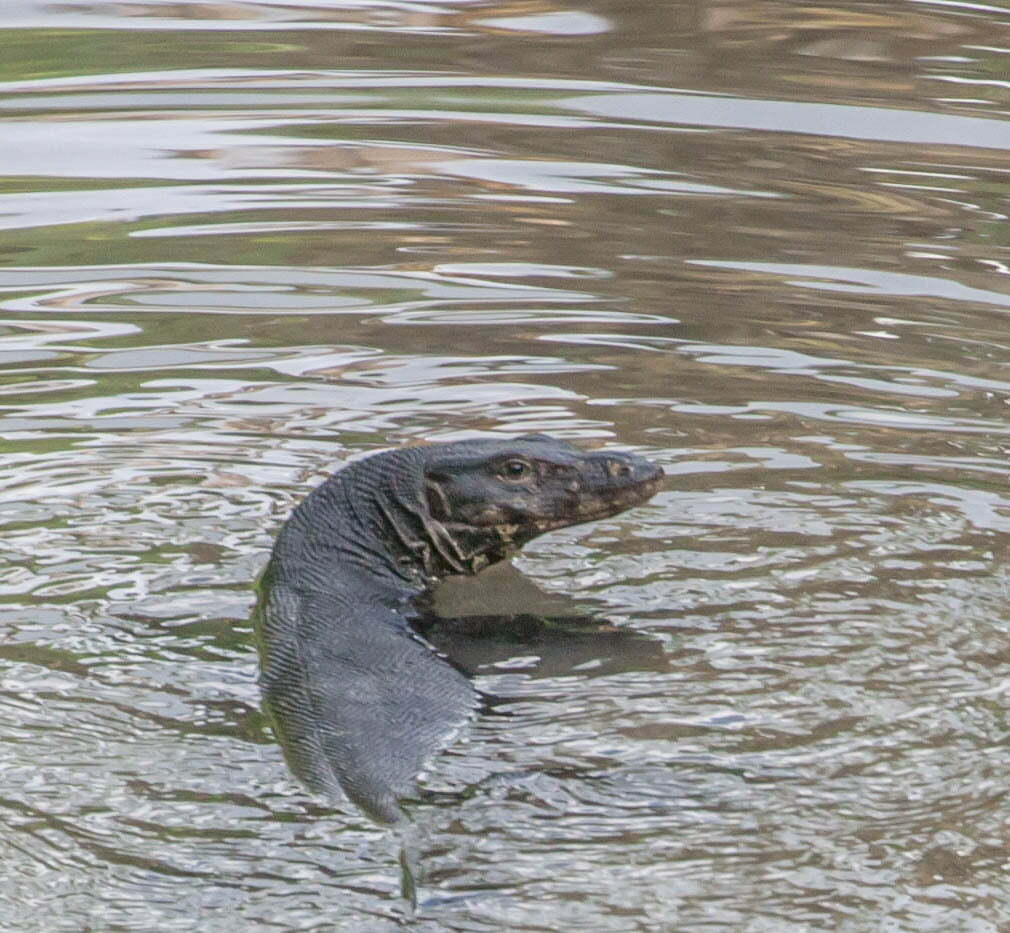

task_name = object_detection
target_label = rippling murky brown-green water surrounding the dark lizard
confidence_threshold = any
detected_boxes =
[0,0,1010,933]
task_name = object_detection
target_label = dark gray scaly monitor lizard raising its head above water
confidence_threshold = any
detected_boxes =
[257,434,664,822]
